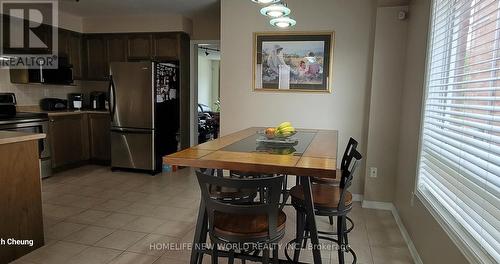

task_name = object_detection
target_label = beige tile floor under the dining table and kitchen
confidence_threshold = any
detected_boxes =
[14,166,413,264]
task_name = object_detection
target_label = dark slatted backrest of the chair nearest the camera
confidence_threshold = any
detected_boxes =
[196,171,283,239]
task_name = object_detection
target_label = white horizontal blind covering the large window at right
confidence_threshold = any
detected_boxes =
[417,0,500,263]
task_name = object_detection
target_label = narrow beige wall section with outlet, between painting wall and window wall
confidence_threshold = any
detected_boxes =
[364,7,408,202]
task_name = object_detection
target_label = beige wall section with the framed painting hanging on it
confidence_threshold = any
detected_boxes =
[221,0,376,193]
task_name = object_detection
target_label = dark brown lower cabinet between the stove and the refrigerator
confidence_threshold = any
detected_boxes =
[48,113,111,170]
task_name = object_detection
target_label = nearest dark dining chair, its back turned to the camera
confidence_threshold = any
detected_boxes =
[196,171,286,264]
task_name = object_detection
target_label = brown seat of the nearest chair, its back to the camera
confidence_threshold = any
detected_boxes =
[214,211,286,238]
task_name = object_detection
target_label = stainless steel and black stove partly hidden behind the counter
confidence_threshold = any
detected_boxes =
[0,93,52,178]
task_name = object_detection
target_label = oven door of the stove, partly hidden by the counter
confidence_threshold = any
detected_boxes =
[0,121,52,178]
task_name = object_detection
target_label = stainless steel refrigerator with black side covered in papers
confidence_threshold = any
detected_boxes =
[109,62,179,174]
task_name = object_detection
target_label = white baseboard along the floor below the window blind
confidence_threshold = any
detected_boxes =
[361,200,423,264]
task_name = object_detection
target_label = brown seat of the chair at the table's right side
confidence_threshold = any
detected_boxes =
[290,184,352,209]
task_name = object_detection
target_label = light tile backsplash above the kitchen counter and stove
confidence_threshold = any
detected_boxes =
[0,69,108,105]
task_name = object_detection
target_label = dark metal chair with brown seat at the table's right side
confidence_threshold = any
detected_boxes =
[285,148,362,264]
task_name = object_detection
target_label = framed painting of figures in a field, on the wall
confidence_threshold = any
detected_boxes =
[252,31,335,93]
